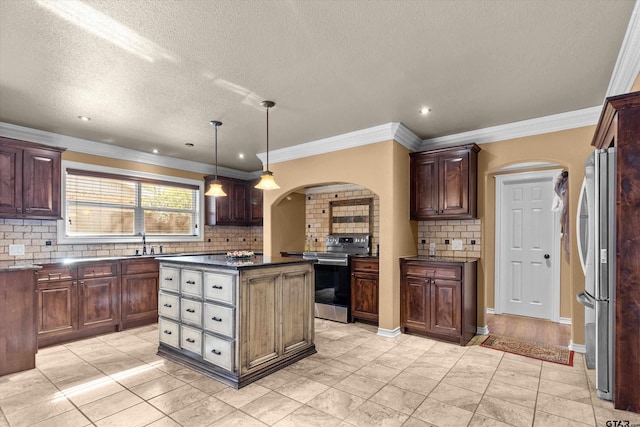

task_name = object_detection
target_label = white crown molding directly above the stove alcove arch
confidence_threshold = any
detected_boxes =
[257,122,422,164]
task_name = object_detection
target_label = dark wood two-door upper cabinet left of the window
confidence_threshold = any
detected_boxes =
[0,137,64,219]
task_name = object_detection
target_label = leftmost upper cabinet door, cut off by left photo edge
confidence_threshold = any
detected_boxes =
[0,145,22,216]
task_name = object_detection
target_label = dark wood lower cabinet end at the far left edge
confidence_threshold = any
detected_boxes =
[0,269,38,376]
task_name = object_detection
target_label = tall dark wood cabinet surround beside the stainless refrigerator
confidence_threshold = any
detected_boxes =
[591,92,640,412]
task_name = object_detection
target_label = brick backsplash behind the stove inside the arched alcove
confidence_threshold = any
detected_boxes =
[305,189,380,253]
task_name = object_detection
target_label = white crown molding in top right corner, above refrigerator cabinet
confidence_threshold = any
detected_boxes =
[607,0,640,97]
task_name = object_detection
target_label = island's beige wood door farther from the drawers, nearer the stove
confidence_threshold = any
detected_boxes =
[281,270,313,354]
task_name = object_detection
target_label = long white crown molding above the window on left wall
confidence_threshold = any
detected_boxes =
[0,122,260,180]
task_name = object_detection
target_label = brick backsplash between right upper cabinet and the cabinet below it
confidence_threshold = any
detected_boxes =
[418,219,482,258]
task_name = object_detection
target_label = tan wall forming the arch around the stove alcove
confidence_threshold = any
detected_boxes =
[264,141,417,330]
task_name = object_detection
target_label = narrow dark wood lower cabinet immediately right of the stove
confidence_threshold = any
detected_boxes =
[351,257,379,324]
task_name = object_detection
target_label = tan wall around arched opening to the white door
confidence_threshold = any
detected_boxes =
[478,126,595,344]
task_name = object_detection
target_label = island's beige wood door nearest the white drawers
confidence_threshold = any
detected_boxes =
[241,270,280,373]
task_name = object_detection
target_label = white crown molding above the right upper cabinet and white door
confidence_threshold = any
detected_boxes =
[420,106,602,150]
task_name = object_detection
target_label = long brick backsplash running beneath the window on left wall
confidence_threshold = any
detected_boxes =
[0,219,263,261]
